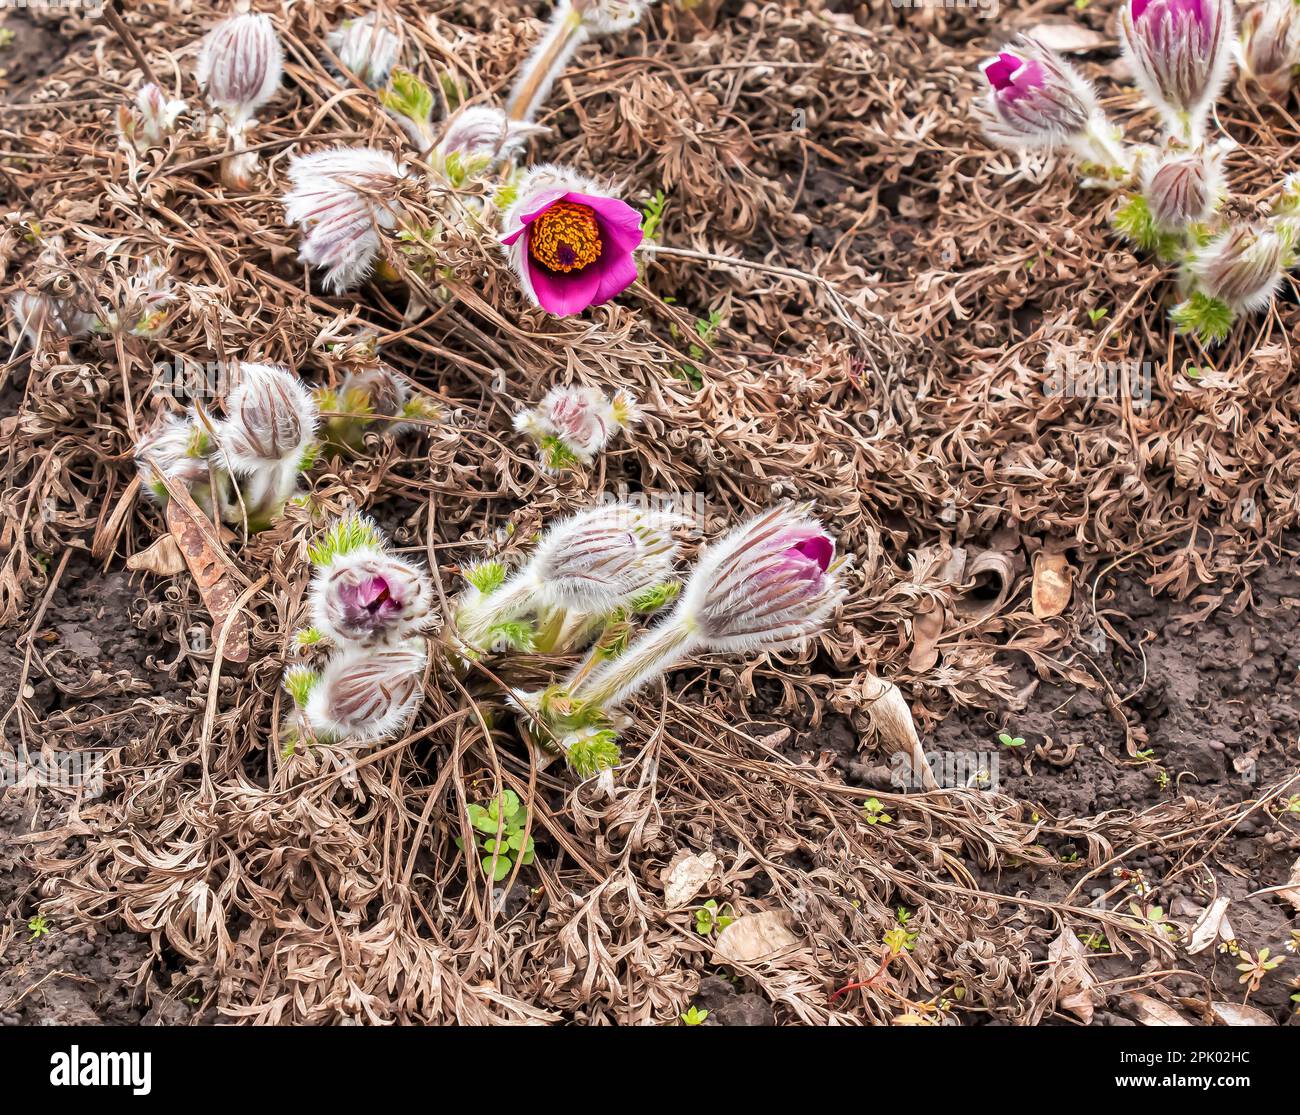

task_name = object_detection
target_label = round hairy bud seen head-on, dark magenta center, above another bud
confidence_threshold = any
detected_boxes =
[311,547,433,645]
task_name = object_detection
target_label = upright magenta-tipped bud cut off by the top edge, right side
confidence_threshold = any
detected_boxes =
[1119,0,1232,144]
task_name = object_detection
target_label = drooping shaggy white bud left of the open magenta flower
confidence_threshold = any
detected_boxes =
[283,148,406,291]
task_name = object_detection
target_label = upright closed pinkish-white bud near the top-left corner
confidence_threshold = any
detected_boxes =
[198,13,285,133]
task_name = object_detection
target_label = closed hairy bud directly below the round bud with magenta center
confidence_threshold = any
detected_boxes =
[306,639,428,743]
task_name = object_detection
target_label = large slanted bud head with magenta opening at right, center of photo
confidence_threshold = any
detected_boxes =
[675,507,844,651]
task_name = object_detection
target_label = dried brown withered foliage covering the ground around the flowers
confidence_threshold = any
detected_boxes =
[0,0,1300,1024]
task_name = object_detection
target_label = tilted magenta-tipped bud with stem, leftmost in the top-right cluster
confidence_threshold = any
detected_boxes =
[978,35,1127,169]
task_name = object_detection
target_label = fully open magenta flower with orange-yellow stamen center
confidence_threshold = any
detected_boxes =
[502,166,642,316]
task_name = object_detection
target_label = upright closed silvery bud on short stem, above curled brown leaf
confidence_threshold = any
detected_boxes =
[217,364,317,528]
